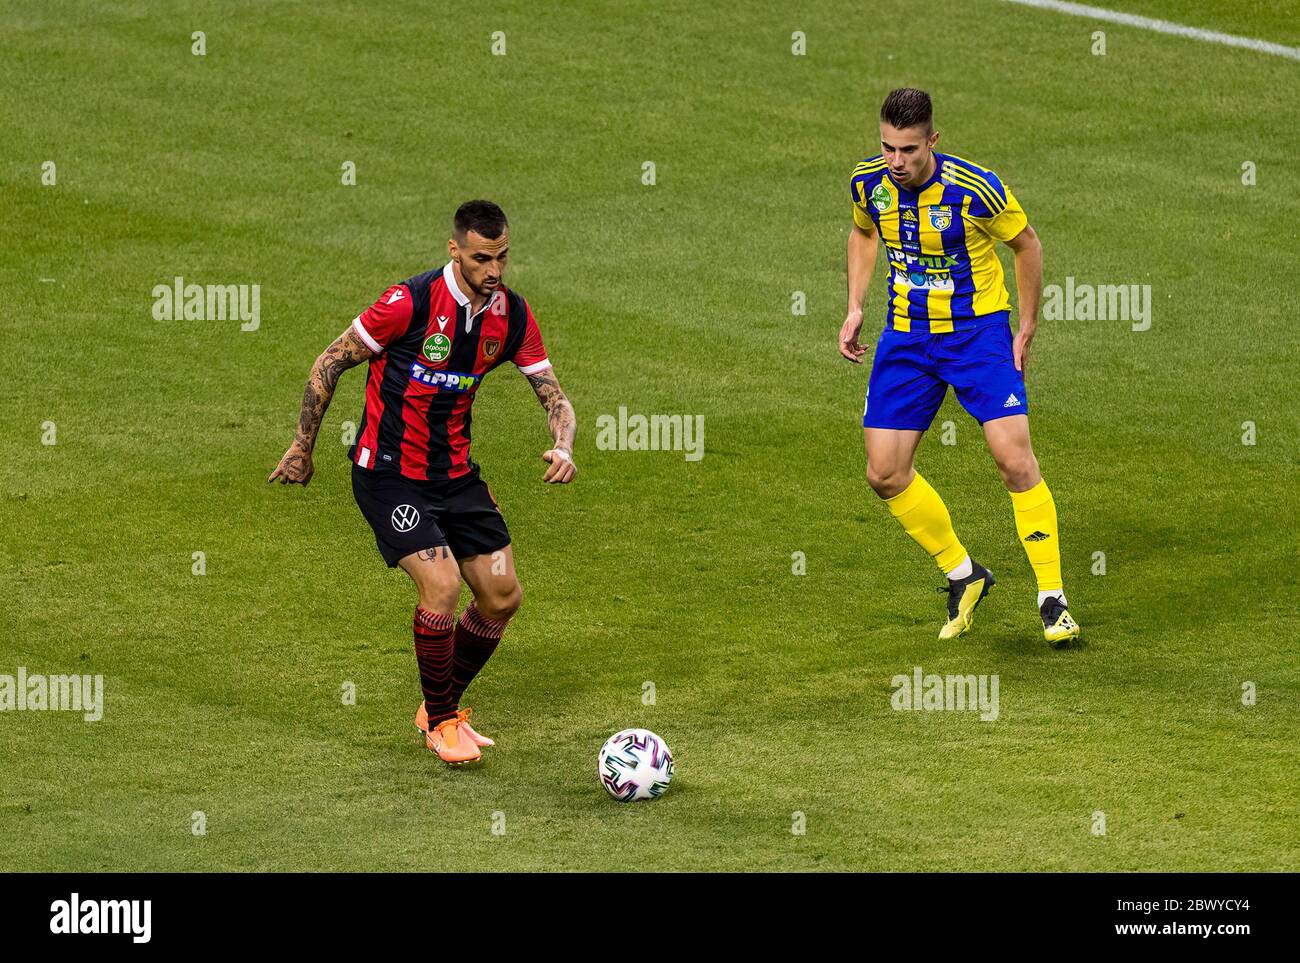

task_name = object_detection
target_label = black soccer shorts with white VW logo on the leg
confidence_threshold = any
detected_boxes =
[352,464,510,568]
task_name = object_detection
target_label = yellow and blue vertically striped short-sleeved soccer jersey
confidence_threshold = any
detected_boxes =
[849,151,1028,334]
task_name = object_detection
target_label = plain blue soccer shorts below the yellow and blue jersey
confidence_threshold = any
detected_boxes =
[862,315,1030,431]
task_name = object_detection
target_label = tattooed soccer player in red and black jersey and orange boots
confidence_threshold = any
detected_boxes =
[268,200,577,763]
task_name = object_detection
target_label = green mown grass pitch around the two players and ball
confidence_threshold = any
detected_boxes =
[0,0,1300,871]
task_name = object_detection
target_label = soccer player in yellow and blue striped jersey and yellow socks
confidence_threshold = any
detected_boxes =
[840,87,1079,645]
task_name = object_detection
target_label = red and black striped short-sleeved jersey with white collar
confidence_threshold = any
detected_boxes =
[348,263,551,480]
